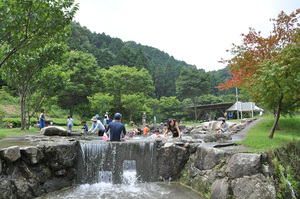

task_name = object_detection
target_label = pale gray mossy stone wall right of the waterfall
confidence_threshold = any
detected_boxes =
[179,146,276,199]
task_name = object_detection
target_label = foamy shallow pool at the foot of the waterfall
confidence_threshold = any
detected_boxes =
[35,182,204,199]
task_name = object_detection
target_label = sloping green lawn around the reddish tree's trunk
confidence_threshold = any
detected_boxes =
[237,115,300,152]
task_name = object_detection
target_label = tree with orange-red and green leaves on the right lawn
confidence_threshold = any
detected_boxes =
[219,9,300,139]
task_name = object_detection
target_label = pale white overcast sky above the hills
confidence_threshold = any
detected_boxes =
[75,0,300,71]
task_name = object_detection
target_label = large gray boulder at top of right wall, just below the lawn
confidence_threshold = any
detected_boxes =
[226,153,261,178]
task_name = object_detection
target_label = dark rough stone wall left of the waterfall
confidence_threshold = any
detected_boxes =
[0,136,78,199]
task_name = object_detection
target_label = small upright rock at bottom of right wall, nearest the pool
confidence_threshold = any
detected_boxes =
[210,178,229,199]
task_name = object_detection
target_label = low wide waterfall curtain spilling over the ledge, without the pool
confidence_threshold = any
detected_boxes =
[77,141,158,184]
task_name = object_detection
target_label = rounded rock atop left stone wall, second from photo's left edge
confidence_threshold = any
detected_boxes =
[20,146,44,164]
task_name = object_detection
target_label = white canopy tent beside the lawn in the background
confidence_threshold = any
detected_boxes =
[227,102,264,119]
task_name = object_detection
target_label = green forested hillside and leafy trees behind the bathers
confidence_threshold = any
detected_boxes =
[0,19,245,123]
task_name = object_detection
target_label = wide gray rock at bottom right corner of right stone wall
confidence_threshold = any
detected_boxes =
[231,177,276,199]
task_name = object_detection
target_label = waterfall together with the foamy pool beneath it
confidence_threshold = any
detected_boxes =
[40,141,203,199]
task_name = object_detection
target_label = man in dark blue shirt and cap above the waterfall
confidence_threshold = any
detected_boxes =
[106,113,126,141]
